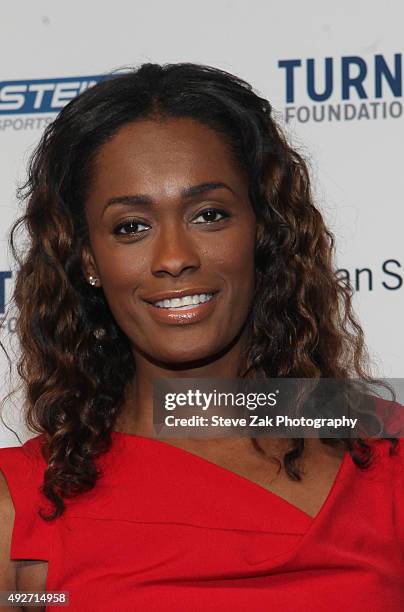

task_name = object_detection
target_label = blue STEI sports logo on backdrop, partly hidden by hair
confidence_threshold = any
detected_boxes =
[0,75,105,131]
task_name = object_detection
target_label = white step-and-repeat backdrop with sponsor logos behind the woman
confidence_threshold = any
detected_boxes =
[0,0,404,446]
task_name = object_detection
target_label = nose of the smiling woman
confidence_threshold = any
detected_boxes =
[151,222,200,276]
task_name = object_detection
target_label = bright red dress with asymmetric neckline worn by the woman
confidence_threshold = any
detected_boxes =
[0,432,404,612]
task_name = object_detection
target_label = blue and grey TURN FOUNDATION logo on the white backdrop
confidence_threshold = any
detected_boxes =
[278,53,403,123]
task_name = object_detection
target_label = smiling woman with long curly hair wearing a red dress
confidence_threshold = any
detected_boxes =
[0,64,404,612]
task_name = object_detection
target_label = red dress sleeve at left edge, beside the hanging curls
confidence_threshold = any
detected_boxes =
[0,435,54,561]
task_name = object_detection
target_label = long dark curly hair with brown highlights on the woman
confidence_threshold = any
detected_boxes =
[3,63,397,520]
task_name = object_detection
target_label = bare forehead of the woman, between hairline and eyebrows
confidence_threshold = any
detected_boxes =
[89,118,248,206]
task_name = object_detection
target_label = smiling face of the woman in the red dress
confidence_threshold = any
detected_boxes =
[83,118,256,364]
